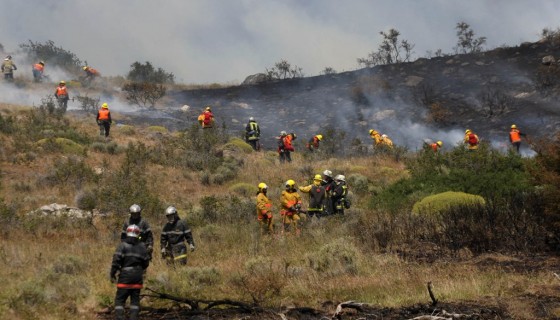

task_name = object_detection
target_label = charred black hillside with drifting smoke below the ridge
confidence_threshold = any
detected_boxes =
[164,42,560,148]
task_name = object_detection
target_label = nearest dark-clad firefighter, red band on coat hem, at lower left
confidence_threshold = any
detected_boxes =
[109,224,150,320]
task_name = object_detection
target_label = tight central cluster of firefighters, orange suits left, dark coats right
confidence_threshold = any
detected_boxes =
[257,170,350,235]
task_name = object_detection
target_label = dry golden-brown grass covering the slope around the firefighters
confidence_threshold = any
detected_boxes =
[0,105,559,319]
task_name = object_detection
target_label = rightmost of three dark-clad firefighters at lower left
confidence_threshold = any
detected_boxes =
[160,206,195,265]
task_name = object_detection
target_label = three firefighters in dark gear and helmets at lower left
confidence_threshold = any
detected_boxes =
[109,204,195,320]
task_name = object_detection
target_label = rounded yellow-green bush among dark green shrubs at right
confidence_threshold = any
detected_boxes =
[412,191,485,215]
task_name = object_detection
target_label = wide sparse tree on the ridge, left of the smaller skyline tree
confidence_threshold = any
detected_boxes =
[358,29,414,68]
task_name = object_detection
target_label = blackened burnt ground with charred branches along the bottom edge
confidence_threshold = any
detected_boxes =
[98,254,560,320]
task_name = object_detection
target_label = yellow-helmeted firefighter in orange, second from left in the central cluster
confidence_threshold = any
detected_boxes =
[280,179,301,235]
